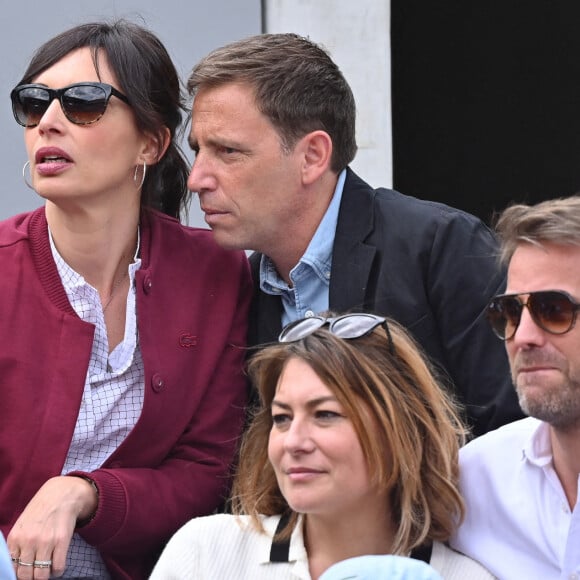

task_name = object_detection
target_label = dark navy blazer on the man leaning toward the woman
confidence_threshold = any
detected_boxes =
[248,169,523,435]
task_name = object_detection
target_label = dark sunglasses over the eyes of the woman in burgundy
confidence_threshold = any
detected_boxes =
[10,82,129,128]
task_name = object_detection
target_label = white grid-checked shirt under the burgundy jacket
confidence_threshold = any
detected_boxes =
[50,230,145,579]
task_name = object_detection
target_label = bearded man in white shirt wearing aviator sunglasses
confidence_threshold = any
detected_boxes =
[452,197,580,580]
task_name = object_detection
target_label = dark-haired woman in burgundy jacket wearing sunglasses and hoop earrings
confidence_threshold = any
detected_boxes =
[0,21,251,580]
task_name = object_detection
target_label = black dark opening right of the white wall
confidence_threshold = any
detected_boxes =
[391,0,580,222]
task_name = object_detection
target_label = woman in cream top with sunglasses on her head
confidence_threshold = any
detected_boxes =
[151,313,492,580]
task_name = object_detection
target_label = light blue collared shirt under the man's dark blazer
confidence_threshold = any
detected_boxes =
[260,169,346,326]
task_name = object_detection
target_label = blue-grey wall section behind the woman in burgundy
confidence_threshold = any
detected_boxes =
[0,0,261,226]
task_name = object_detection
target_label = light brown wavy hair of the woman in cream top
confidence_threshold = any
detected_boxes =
[232,320,466,554]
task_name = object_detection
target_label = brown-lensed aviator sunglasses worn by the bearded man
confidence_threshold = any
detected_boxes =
[486,290,580,340]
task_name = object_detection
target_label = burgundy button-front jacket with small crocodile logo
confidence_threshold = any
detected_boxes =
[0,208,251,580]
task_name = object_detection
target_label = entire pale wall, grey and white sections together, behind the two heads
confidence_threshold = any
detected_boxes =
[0,0,392,225]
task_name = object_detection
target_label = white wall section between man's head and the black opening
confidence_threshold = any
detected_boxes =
[264,0,393,187]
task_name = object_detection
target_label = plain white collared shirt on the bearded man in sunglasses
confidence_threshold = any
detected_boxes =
[451,418,580,580]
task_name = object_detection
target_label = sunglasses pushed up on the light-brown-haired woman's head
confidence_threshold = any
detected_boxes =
[278,312,393,352]
